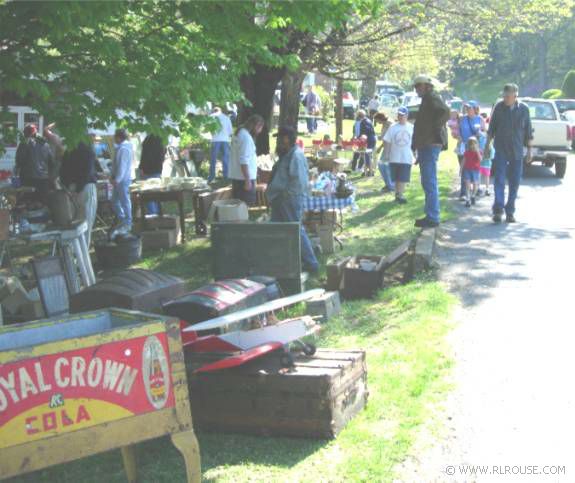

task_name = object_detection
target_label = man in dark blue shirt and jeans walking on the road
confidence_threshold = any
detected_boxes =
[485,84,533,223]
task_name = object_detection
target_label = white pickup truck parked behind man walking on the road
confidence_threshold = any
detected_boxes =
[520,97,573,178]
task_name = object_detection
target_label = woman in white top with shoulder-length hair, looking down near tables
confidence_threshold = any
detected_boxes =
[229,114,264,206]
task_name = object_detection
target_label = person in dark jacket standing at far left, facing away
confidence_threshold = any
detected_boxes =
[15,124,56,203]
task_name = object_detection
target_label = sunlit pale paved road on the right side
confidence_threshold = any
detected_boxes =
[402,162,575,483]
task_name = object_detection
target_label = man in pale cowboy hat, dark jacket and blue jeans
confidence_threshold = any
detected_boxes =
[412,75,449,228]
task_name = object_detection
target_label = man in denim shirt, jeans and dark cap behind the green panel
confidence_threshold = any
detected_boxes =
[266,126,319,272]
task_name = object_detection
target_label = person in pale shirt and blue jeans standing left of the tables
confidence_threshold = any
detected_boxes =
[112,129,134,232]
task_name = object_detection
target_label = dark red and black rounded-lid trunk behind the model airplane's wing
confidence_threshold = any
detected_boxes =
[163,279,268,324]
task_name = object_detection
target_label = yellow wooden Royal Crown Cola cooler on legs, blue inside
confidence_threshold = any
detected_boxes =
[0,309,200,482]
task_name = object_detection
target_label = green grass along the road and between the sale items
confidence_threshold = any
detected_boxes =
[6,133,457,483]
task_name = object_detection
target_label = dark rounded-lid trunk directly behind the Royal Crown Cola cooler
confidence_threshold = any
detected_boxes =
[70,269,186,313]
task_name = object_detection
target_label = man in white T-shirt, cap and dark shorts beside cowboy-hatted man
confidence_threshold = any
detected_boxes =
[383,107,414,204]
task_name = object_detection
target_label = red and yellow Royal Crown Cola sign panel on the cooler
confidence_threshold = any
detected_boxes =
[0,332,174,449]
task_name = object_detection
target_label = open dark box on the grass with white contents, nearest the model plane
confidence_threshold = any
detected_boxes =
[343,255,384,299]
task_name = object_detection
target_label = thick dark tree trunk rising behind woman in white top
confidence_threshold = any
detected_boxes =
[238,64,285,156]
